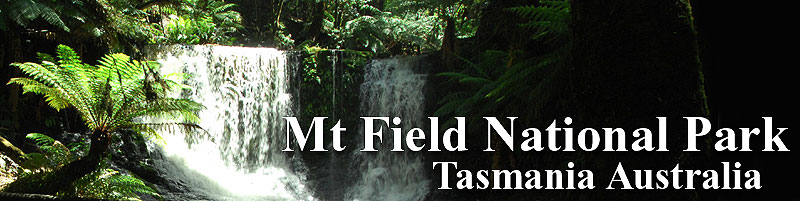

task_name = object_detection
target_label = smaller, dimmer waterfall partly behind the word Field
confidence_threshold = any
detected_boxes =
[348,56,429,201]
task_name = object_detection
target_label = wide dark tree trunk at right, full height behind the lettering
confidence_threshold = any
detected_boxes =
[571,0,708,200]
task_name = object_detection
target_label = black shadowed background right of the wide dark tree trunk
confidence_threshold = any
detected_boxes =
[693,1,800,200]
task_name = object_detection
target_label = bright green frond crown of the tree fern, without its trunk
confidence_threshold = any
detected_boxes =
[9,45,203,135]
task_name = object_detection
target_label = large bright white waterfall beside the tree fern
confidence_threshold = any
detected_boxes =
[151,46,315,200]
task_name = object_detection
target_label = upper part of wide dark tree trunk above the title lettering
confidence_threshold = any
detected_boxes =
[572,0,707,133]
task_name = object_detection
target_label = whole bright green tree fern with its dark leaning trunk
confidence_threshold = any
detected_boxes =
[6,45,203,193]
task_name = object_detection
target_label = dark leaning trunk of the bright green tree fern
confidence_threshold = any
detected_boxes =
[5,131,111,195]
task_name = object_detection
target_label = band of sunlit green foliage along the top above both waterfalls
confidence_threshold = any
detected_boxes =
[0,0,489,54]
